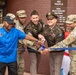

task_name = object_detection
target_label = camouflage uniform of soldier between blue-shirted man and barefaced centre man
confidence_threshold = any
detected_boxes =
[16,20,24,75]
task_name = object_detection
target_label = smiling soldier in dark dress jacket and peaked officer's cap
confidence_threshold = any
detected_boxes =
[38,12,64,75]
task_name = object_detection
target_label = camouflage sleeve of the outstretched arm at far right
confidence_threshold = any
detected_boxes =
[49,29,76,50]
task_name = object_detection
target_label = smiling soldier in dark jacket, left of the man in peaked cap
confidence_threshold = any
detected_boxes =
[24,10,43,75]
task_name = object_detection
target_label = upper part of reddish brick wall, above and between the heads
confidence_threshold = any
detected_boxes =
[6,0,76,23]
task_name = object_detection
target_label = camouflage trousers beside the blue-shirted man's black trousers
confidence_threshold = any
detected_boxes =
[17,50,24,75]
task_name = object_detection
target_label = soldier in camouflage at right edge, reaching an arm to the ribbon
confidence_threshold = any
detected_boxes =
[44,14,76,75]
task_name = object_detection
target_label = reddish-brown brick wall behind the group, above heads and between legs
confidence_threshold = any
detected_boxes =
[6,0,76,75]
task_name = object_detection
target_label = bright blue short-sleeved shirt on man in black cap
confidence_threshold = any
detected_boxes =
[0,27,26,63]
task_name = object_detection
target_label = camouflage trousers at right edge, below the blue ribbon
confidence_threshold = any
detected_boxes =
[70,50,76,75]
